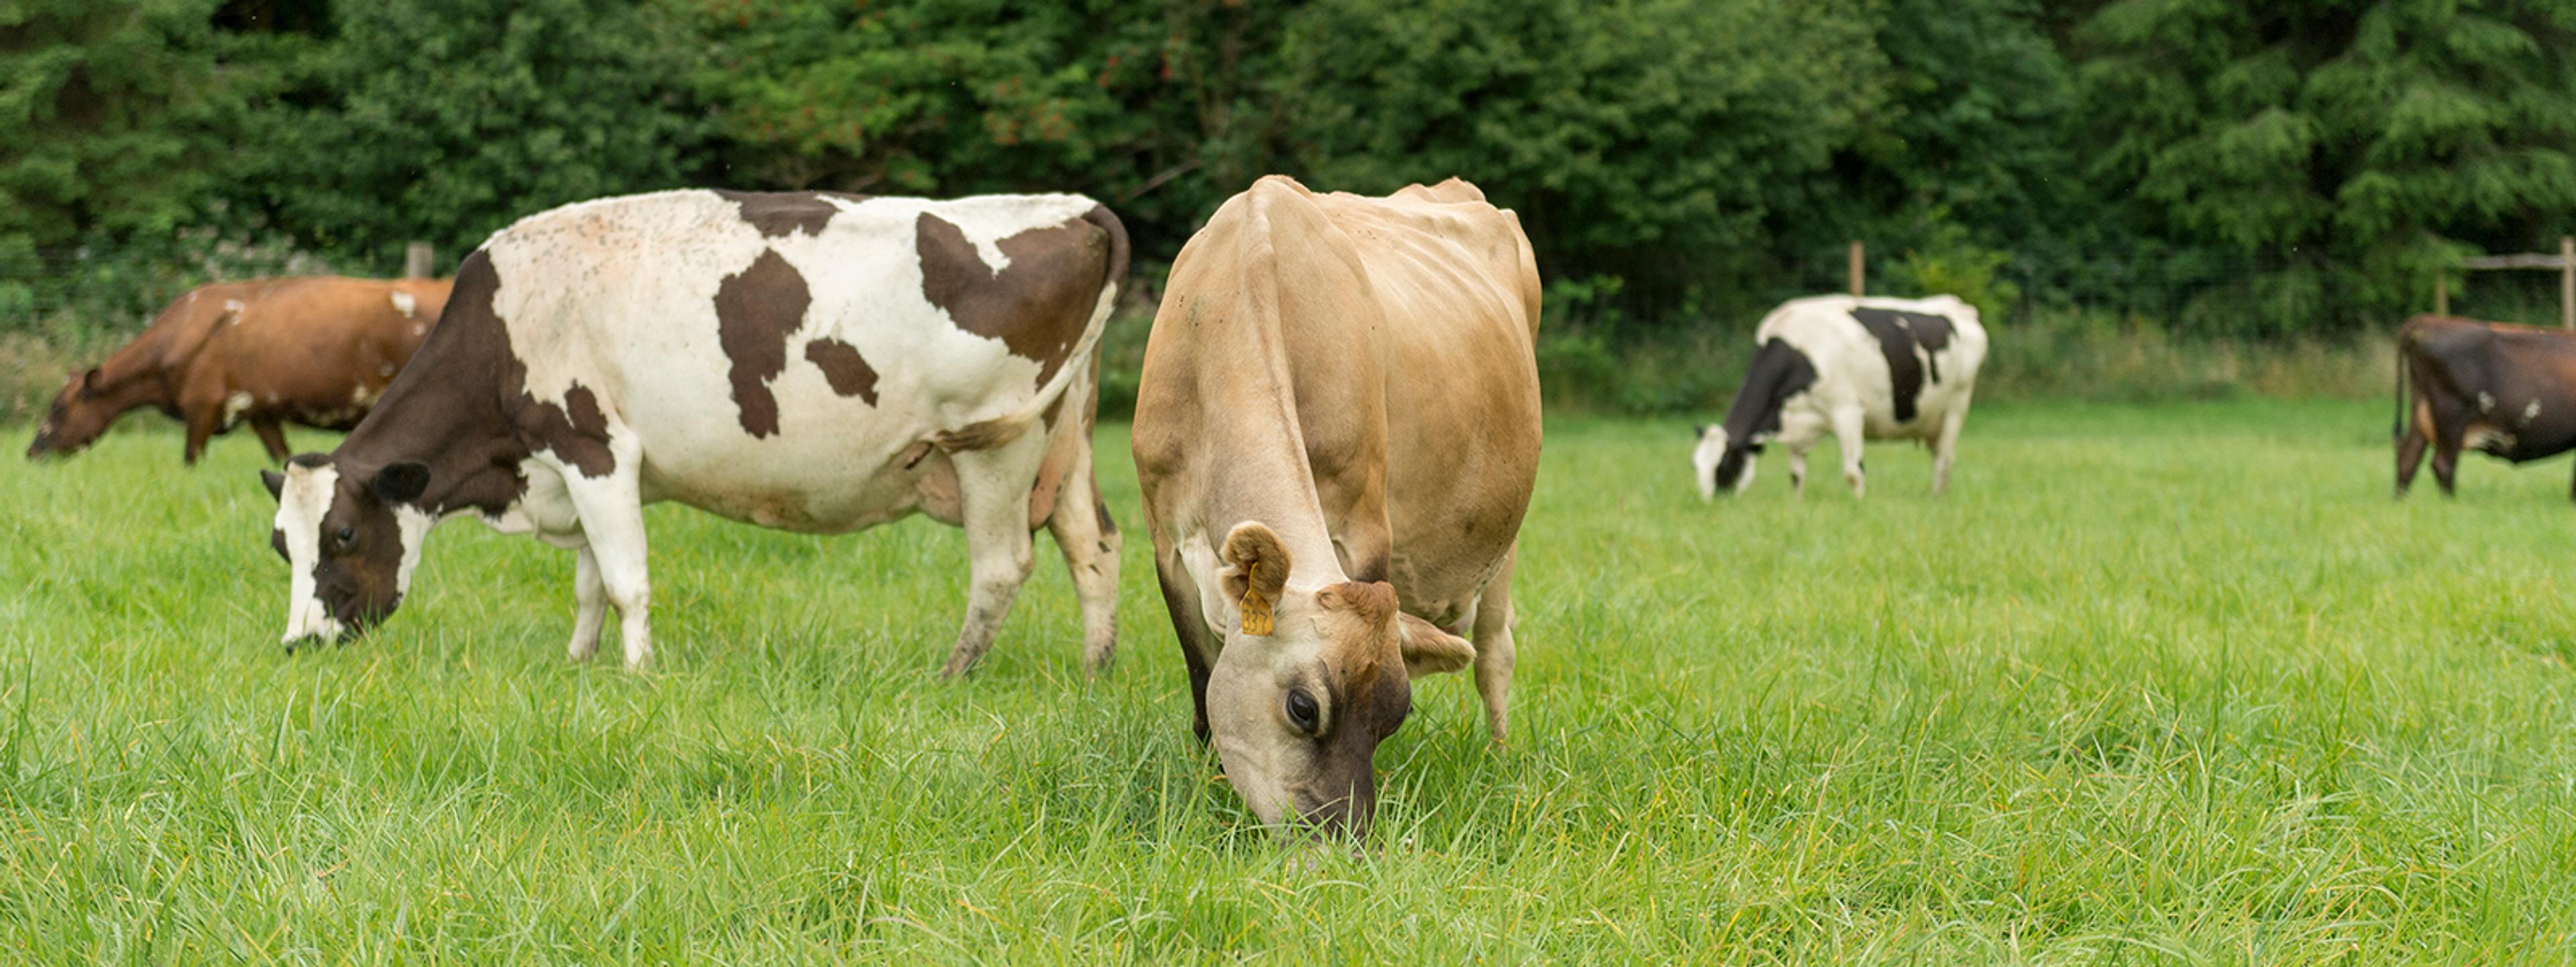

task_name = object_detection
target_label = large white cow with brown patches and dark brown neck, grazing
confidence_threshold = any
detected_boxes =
[266,191,1128,676]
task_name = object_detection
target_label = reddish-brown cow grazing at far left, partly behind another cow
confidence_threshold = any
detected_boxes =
[25,276,451,464]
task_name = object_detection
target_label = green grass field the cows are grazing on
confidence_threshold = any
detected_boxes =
[0,400,2576,964]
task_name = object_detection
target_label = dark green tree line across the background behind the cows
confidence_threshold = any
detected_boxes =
[0,0,2576,336]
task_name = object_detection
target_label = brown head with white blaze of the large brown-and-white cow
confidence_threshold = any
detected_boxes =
[260,454,435,648]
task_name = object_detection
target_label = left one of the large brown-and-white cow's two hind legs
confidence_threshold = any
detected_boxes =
[941,434,1046,678]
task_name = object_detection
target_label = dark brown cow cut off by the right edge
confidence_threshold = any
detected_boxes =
[2393,315,2576,498]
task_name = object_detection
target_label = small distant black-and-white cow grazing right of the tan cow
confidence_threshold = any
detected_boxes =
[1690,297,1986,500]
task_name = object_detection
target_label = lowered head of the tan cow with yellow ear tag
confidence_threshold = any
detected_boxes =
[1208,523,1476,835]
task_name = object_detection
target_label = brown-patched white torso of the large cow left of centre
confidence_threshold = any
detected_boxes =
[443,191,1110,531]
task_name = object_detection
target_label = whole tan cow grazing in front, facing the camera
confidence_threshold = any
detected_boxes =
[1134,175,1540,835]
